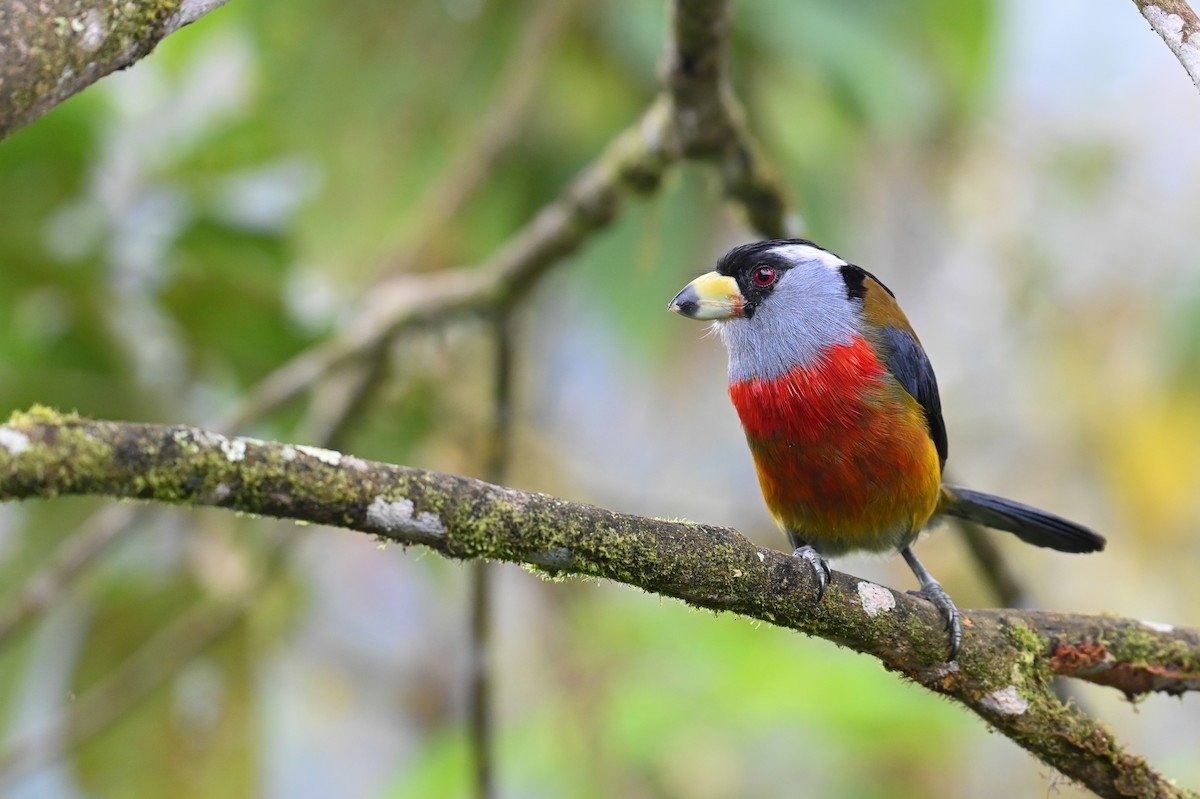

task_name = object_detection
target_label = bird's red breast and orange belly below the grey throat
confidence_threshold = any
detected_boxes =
[730,340,942,555]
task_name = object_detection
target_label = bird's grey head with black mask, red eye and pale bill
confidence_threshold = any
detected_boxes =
[668,239,874,380]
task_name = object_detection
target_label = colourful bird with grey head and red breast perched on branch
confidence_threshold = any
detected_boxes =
[667,239,1105,661]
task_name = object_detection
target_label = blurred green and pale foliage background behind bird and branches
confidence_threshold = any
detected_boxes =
[0,0,1200,799]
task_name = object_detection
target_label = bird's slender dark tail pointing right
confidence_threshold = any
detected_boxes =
[940,486,1104,552]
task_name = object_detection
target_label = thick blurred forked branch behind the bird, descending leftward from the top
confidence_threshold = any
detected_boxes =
[229,0,788,427]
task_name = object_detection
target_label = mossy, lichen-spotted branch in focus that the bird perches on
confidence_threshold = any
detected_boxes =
[0,408,1200,797]
